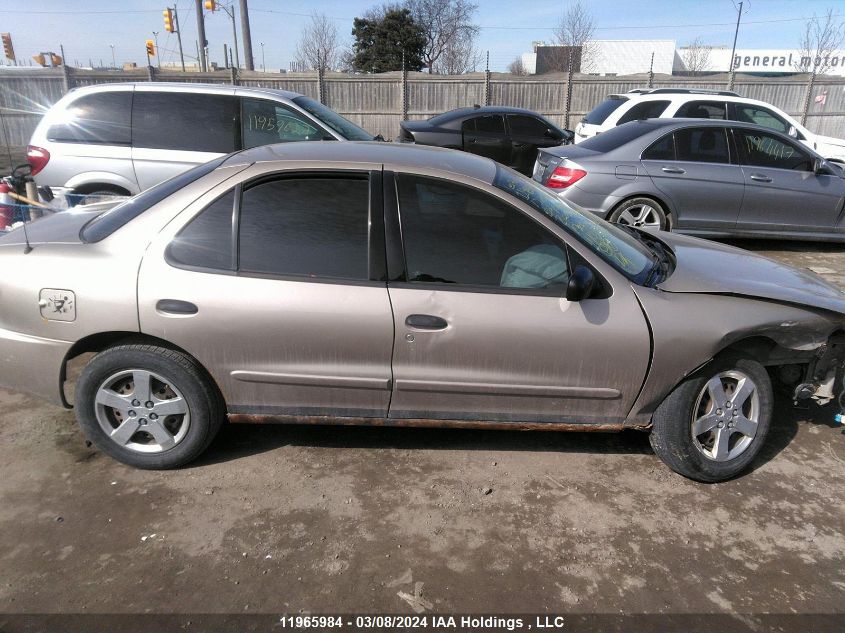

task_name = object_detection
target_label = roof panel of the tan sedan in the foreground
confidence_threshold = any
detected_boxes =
[221,141,496,183]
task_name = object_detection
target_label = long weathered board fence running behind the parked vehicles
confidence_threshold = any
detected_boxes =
[0,67,845,146]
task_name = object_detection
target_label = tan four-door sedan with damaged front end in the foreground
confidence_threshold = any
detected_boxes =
[0,143,845,482]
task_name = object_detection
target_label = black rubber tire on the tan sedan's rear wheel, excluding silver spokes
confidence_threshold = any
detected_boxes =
[74,344,225,470]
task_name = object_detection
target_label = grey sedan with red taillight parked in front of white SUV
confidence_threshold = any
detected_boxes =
[534,119,845,240]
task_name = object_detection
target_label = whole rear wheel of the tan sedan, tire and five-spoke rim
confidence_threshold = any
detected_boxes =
[74,344,225,469]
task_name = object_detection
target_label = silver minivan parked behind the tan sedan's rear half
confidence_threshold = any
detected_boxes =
[27,82,373,197]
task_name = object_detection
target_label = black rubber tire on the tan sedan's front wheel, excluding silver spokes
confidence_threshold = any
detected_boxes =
[649,358,773,483]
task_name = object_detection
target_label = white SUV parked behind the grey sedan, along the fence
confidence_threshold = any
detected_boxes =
[575,88,845,162]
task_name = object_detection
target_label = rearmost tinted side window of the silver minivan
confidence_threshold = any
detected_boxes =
[47,91,132,145]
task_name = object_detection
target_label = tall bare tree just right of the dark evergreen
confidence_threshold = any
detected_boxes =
[405,0,479,75]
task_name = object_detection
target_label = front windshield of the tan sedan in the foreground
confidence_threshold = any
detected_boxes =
[493,165,655,284]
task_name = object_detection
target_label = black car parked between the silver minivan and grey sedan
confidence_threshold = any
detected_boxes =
[398,106,573,175]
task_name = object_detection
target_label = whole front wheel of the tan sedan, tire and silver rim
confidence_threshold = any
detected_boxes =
[650,359,772,483]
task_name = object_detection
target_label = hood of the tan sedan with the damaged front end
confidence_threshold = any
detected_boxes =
[656,232,845,314]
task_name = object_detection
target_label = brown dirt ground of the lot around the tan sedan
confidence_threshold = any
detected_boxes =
[0,243,845,631]
